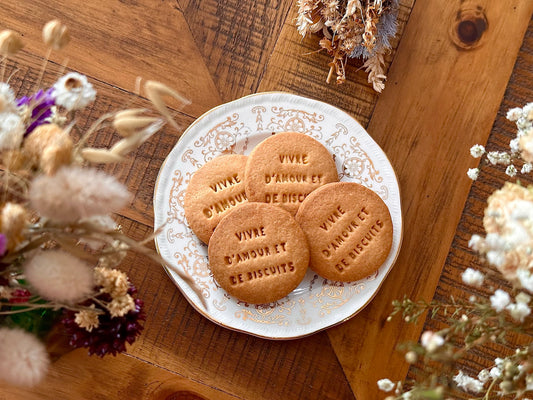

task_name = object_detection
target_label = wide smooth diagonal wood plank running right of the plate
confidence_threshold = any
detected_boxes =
[322,0,533,399]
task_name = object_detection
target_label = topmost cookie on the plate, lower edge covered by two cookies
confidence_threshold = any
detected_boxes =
[244,132,339,215]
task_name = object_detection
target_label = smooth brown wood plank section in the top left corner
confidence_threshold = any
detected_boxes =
[0,0,220,117]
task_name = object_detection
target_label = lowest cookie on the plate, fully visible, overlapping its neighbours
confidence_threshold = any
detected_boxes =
[208,203,309,304]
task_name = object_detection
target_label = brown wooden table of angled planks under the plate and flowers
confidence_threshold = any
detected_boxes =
[0,0,533,400]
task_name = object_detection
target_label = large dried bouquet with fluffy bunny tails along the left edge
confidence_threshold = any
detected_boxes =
[0,20,190,386]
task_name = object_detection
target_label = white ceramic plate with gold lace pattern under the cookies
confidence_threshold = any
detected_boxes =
[154,92,402,339]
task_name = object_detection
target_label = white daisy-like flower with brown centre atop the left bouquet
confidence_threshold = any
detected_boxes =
[53,72,96,111]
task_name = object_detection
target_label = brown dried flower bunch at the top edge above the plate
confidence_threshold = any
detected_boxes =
[296,0,399,93]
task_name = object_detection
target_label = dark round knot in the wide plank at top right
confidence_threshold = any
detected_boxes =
[450,5,489,50]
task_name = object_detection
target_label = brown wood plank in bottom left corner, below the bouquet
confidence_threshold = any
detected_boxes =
[0,350,241,400]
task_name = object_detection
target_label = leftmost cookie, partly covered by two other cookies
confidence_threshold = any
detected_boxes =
[183,154,247,243]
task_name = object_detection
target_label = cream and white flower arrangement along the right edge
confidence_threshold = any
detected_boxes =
[378,103,533,400]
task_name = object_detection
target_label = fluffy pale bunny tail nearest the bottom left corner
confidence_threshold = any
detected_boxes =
[0,327,50,386]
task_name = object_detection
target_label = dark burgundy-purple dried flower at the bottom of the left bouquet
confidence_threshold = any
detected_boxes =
[61,286,146,357]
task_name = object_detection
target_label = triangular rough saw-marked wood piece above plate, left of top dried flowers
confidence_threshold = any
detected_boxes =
[178,0,293,101]
